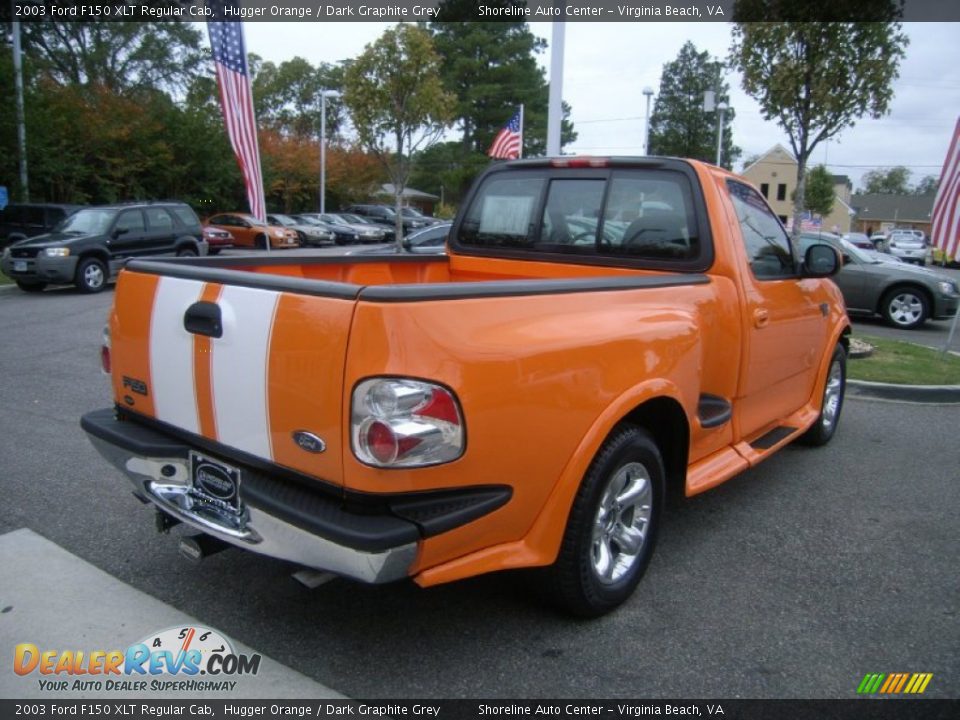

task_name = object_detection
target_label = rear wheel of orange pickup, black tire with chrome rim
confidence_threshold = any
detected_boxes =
[543,425,666,617]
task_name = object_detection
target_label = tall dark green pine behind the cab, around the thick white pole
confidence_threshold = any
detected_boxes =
[427,7,577,159]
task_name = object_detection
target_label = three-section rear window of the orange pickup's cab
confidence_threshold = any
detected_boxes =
[458,169,705,266]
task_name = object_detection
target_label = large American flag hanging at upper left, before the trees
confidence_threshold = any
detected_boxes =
[207,0,266,220]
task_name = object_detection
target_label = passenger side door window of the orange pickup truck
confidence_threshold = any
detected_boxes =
[727,180,794,279]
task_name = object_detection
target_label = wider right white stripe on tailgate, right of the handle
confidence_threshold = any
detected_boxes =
[212,286,280,460]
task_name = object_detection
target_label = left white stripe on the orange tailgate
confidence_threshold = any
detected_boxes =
[150,277,203,433]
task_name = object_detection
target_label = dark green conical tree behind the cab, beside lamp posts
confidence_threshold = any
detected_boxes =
[650,42,740,170]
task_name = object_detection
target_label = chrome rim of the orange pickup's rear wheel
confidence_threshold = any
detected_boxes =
[591,462,653,585]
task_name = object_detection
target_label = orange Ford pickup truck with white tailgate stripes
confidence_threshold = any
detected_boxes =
[82,157,850,616]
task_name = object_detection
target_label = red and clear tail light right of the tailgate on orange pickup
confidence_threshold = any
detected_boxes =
[350,378,465,467]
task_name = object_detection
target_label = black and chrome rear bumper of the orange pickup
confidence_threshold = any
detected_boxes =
[80,408,512,583]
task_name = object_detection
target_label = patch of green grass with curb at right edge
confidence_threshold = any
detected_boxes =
[847,335,960,385]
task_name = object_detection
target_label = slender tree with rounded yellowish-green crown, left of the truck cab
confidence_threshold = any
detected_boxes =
[344,24,454,249]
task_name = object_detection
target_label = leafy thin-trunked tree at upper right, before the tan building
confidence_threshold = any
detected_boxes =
[730,9,908,235]
